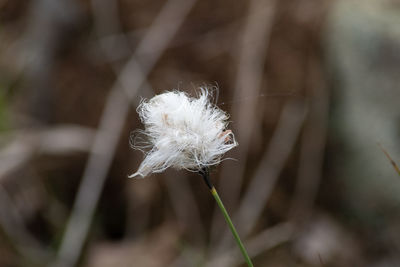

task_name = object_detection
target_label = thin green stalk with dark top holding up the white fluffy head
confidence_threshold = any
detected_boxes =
[200,168,254,267]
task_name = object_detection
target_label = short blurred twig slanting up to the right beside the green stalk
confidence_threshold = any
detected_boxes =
[216,100,307,253]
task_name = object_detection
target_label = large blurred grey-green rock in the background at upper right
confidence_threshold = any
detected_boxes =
[324,0,400,219]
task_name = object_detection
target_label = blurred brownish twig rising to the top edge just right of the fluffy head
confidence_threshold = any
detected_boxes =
[211,0,275,241]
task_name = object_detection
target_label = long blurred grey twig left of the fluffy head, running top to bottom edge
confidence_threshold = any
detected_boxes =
[53,0,195,267]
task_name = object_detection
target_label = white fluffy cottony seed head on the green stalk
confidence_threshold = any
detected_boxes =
[129,88,237,178]
